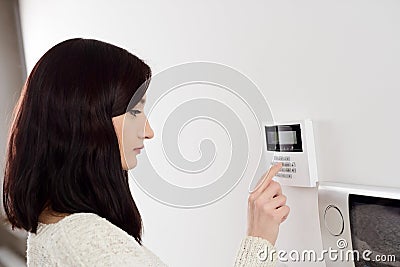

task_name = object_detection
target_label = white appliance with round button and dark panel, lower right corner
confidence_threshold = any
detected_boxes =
[318,183,400,267]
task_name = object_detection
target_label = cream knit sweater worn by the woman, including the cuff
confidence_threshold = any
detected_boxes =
[27,213,277,267]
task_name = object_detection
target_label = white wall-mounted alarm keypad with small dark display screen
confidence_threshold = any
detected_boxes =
[265,120,318,187]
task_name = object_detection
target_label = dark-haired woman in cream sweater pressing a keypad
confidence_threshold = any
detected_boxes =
[3,39,289,266]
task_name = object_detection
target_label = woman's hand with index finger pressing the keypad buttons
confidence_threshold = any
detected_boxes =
[247,163,290,245]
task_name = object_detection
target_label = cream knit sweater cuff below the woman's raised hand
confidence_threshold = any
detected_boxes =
[234,236,277,267]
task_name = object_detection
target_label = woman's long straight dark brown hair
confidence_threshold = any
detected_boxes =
[3,38,151,245]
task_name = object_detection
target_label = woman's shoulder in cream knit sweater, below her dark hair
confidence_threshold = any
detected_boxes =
[27,213,153,266]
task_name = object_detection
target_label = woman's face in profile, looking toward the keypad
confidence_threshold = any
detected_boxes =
[112,96,154,170]
